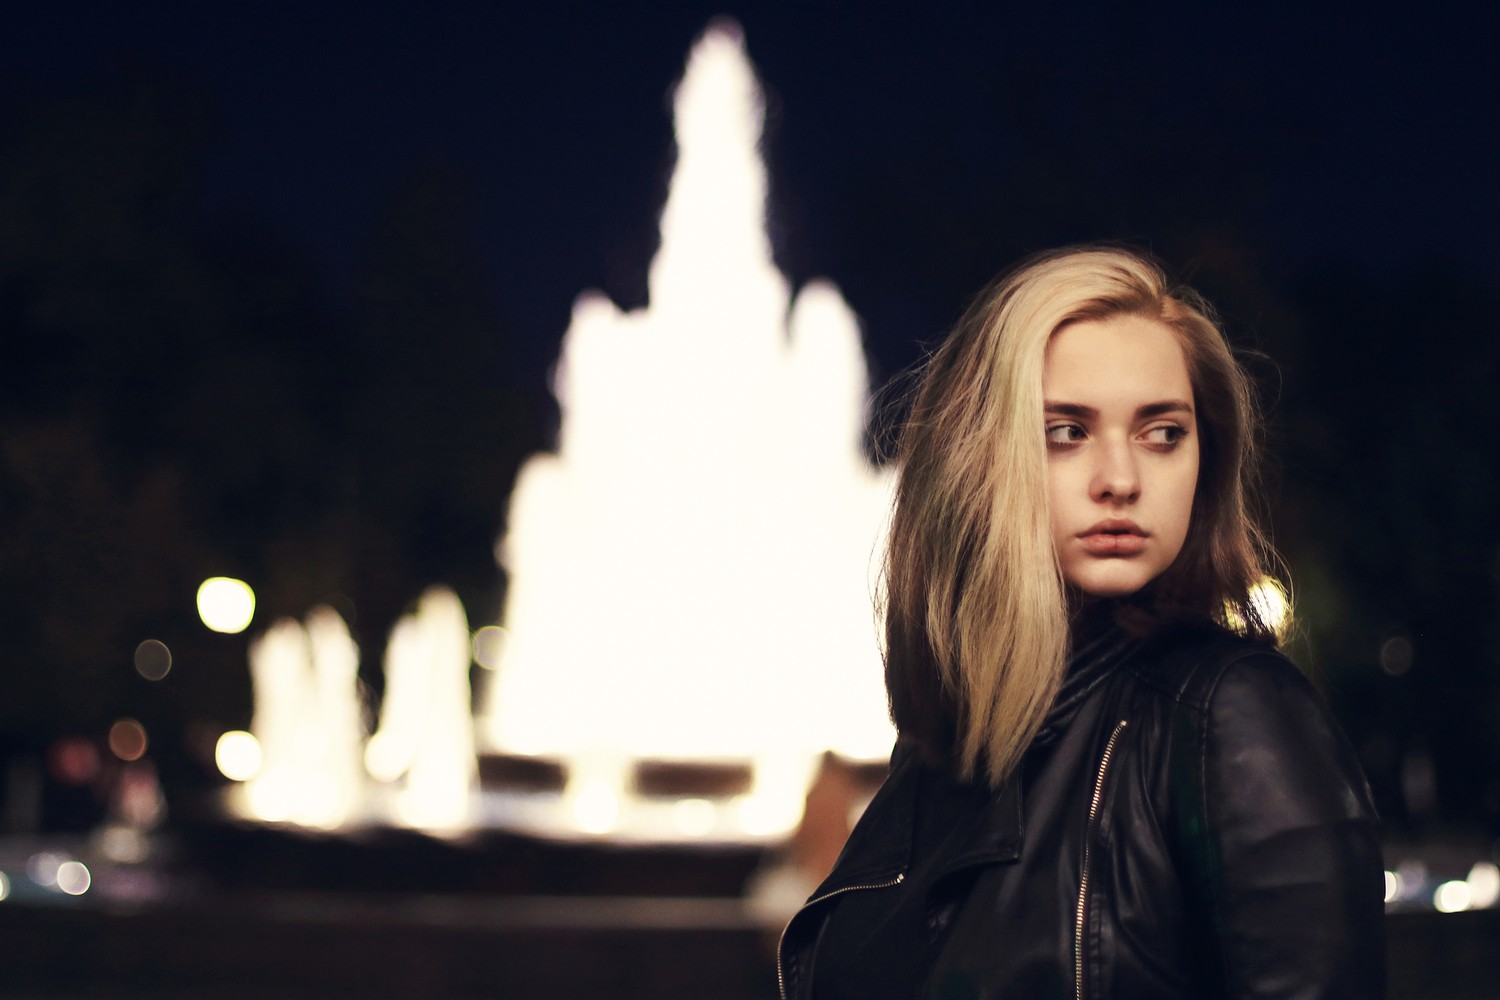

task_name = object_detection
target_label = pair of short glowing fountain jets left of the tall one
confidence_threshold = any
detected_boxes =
[219,588,477,834]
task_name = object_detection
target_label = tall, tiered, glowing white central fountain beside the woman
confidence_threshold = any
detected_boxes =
[480,21,894,840]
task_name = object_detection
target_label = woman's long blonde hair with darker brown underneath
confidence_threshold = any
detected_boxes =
[885,247,1274,784]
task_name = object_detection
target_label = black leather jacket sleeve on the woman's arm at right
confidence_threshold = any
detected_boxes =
[1185,651,1385,1000]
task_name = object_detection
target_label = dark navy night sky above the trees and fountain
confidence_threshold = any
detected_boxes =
[0,3,1500,361]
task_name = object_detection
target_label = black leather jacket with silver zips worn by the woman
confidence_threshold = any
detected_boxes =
[779,628,1385,1000]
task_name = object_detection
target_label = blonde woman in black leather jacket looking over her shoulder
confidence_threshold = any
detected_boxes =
[779,247,1385,1000]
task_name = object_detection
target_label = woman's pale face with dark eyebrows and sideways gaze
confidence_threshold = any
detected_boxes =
[1043,315,1199,597]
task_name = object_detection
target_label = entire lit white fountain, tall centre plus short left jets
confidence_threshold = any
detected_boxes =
[219,28,894,841]
